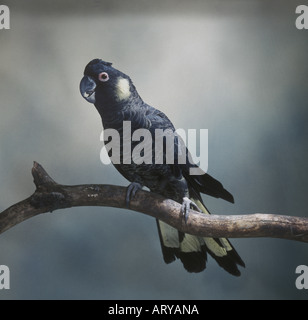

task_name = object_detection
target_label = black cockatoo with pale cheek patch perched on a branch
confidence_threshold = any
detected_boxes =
[80,59,245,276]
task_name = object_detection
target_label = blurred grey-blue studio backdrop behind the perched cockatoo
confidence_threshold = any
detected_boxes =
[0,0,308,300]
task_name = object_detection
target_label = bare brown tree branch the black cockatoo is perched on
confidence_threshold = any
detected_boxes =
[0,162,308,242]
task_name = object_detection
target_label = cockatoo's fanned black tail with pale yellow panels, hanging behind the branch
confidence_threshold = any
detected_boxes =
[157,198,245,276]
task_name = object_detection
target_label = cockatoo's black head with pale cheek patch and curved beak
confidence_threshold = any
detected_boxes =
[80,59,134,106]
